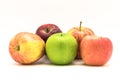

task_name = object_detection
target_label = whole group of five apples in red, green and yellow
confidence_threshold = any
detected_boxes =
[9,21,113,66]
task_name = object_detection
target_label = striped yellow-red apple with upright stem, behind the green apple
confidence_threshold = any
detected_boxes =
[68,21,95,59]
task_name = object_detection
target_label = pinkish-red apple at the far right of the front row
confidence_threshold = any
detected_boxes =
[80,36,113,66]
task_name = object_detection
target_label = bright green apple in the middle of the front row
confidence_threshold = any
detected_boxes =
[45,33,78,65]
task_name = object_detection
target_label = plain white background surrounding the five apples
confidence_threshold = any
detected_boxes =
[0,0,120,82]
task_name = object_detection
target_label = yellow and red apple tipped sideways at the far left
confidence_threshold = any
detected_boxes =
[9,32,45,64]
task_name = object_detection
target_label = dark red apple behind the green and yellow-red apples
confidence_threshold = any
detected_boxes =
[36,24,62,42]
